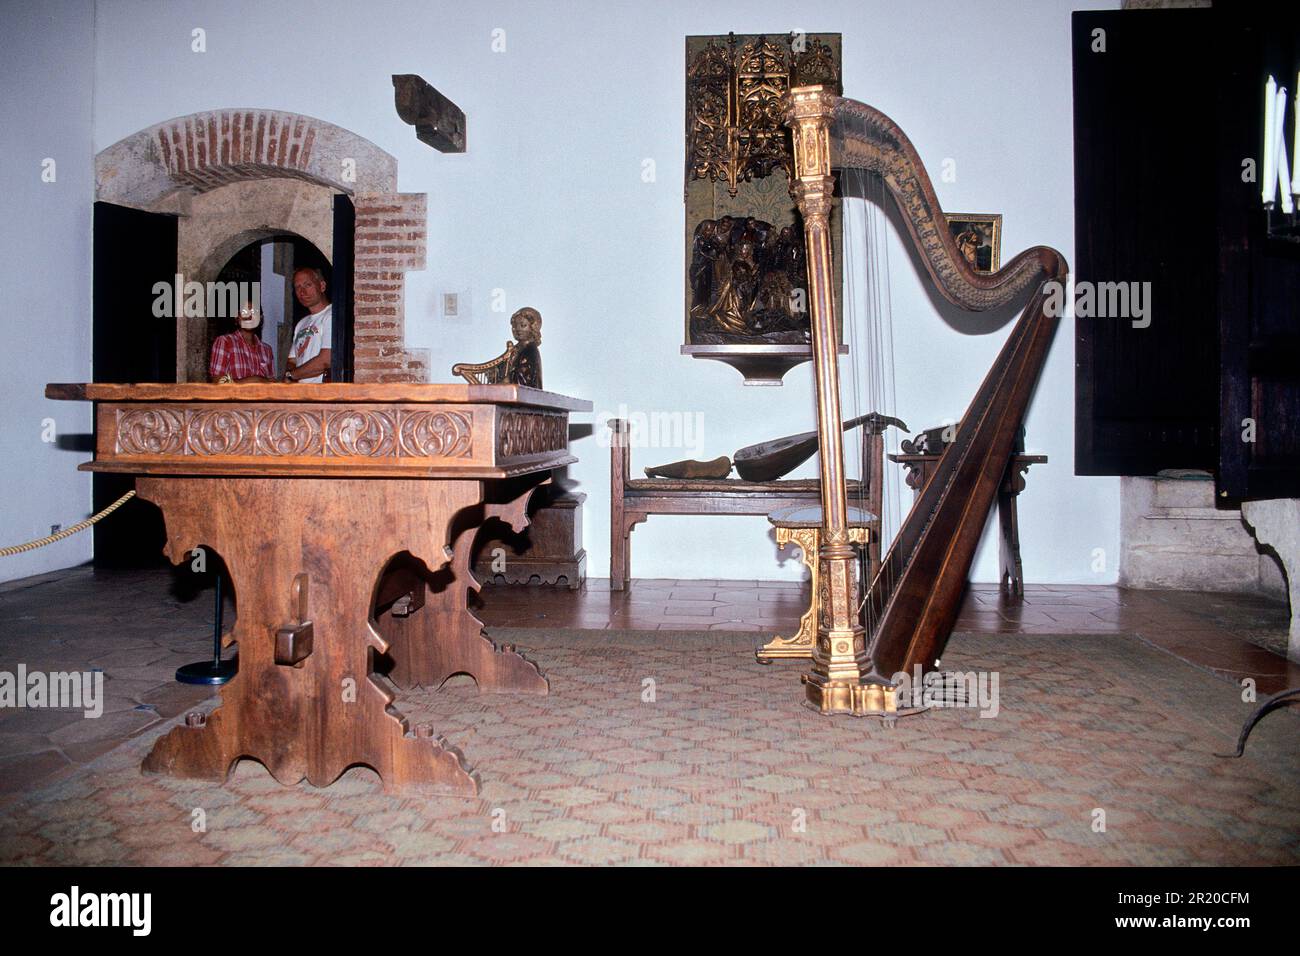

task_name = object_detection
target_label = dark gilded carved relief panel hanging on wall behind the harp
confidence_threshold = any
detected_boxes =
[683,34,840,385]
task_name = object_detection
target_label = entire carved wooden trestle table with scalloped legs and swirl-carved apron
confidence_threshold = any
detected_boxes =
[46,384,592,795]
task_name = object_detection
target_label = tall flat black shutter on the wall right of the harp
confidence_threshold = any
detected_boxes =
[1073,9,1219,475]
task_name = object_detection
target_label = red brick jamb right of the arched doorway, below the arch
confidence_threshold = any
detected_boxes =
[352,193,429,382]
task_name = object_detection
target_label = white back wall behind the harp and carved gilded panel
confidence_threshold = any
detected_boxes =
[15,0,1119,583]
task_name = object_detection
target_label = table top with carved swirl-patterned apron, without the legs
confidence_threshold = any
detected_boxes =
[47,382,585,477]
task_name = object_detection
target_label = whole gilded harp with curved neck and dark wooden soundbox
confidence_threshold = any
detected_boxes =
[788,86,1067,718]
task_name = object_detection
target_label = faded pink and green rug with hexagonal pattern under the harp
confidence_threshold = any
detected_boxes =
[0,627,1300,866]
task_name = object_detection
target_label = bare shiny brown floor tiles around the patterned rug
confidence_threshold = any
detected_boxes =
[0,568,1300,803]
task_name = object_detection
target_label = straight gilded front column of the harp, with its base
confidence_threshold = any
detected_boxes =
[787,86,894,715]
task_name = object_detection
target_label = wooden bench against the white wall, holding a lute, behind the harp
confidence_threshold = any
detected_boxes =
[610,419,884,591]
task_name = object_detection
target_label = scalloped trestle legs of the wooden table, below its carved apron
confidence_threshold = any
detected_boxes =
[137,476,512,796]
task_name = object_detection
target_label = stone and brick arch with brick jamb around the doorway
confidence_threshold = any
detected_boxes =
[95,109,429,382]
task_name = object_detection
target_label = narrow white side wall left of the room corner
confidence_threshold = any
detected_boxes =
[0,0,95,581]
